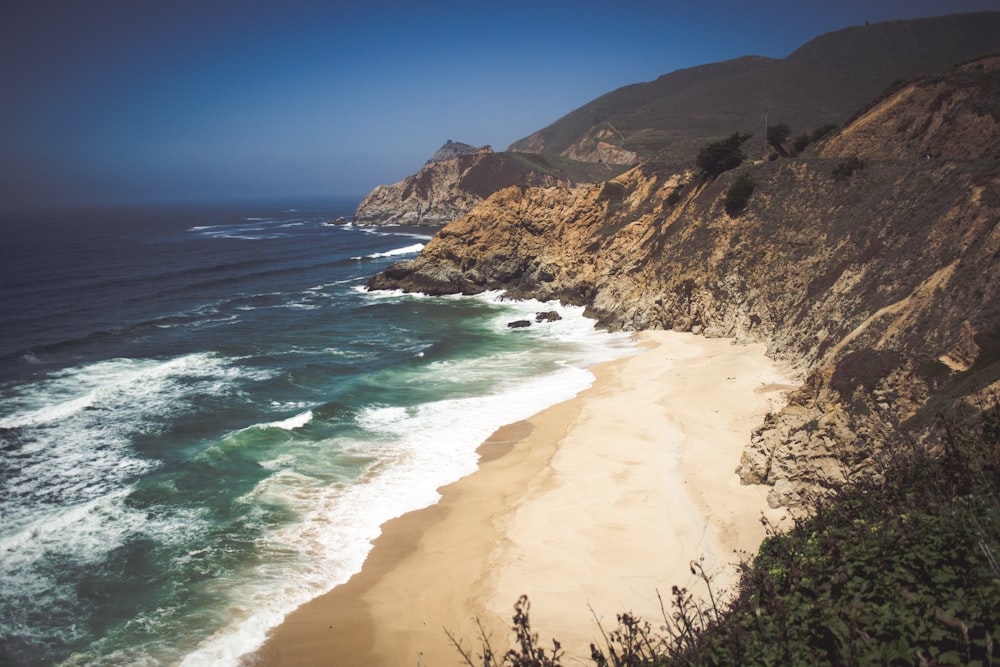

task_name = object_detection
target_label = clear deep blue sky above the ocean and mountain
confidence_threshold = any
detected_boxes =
[0,0,1000,207]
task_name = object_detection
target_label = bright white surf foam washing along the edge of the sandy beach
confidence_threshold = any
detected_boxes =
[182,304,632,665]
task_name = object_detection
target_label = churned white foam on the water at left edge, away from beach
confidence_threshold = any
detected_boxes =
[0,353,290,664]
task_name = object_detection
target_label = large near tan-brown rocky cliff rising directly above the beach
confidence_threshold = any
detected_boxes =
[370,57,1000,505]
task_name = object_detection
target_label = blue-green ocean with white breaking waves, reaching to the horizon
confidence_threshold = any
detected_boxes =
[0,199,635,665]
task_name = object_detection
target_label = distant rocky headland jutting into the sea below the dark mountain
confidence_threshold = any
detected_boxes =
[354,140,621,225]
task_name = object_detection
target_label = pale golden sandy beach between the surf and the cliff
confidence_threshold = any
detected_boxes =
[253,332,792,667]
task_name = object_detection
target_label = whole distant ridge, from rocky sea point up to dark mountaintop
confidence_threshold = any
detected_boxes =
[354,12,1000,225]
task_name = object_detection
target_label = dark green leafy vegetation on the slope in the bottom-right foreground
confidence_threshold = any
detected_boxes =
[463,406,1000,667]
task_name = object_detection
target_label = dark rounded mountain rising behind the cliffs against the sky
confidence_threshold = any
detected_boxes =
[508,12,1000,165]
